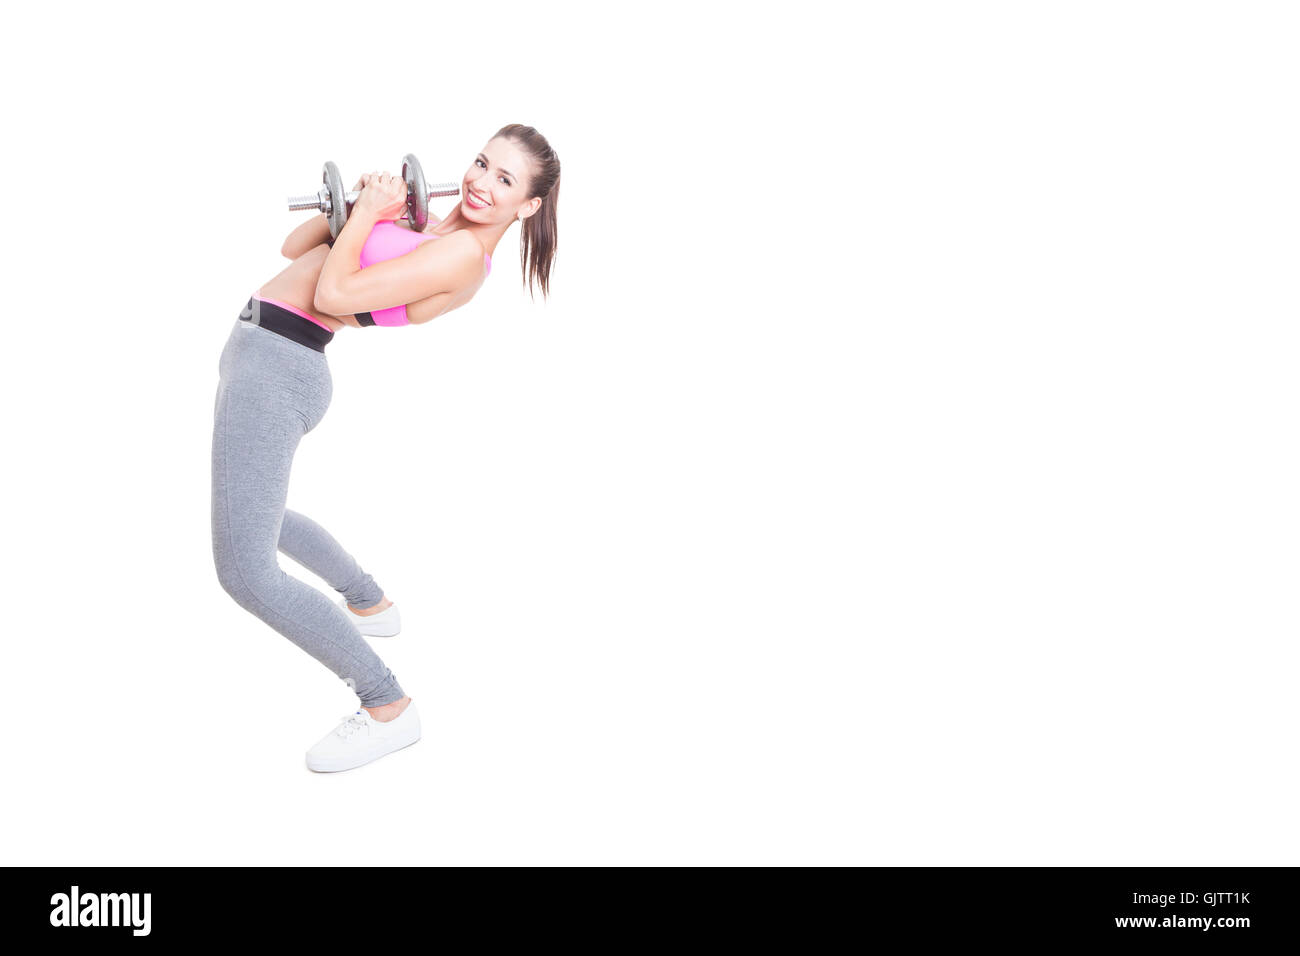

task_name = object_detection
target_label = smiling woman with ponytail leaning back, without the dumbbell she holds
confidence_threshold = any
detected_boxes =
[212,124,560,771]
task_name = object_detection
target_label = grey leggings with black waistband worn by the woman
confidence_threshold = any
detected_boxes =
[212,320,406,708]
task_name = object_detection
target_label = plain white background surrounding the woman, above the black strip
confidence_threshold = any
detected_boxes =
[0,0,1300,868]
